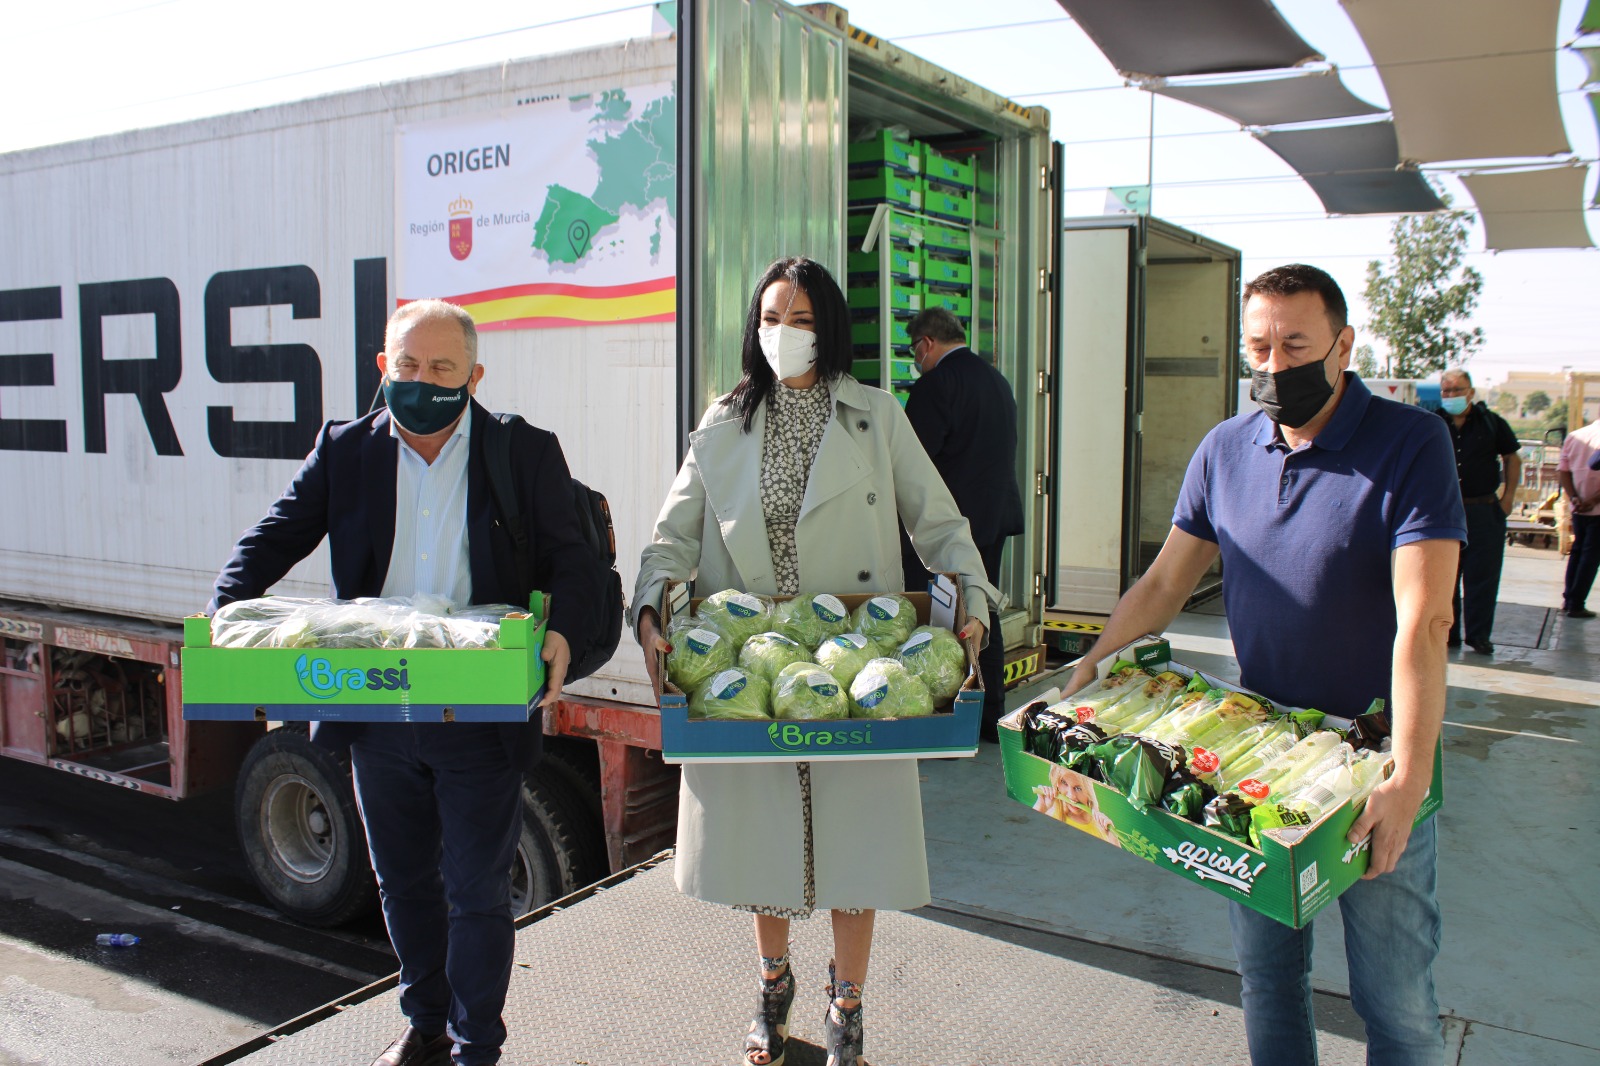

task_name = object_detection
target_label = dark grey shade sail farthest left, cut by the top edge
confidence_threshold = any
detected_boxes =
[1059,0,1322,77]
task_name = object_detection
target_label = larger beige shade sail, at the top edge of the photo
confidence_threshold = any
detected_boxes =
[1341,0,1570,163]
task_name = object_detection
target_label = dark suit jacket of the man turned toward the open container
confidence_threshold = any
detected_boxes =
[906,347,1022,549]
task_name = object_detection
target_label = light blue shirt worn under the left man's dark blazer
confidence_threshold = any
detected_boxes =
[384,410,472,607]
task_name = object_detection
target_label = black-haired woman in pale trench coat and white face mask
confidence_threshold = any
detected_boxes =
[634,259,1000,1066]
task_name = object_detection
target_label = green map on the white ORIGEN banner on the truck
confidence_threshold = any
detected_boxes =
[533,90,678,262]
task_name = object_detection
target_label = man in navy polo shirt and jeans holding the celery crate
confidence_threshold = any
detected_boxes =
[1069,266,1466,1066]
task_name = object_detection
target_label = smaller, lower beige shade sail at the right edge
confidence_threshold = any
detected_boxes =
[1461,166,1594,251]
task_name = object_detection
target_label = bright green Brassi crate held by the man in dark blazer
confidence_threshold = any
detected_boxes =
[182,592,547,722]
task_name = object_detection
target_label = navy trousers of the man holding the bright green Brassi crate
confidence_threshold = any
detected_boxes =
[350,722,522,1066]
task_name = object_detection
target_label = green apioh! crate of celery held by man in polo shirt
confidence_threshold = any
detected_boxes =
[1000,637,1443,928]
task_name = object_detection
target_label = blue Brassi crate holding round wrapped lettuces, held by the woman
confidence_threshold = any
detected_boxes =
[656,575,984,763]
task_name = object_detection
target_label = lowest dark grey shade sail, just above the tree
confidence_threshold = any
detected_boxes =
[1258,122,1445,214]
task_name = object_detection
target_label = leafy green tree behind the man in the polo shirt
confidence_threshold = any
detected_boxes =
[1366,190,1483,378]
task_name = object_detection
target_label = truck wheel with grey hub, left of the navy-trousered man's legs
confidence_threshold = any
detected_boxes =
[234,725,378,925]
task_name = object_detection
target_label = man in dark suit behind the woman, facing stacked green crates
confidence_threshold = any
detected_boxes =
[901,307,1022,741]
